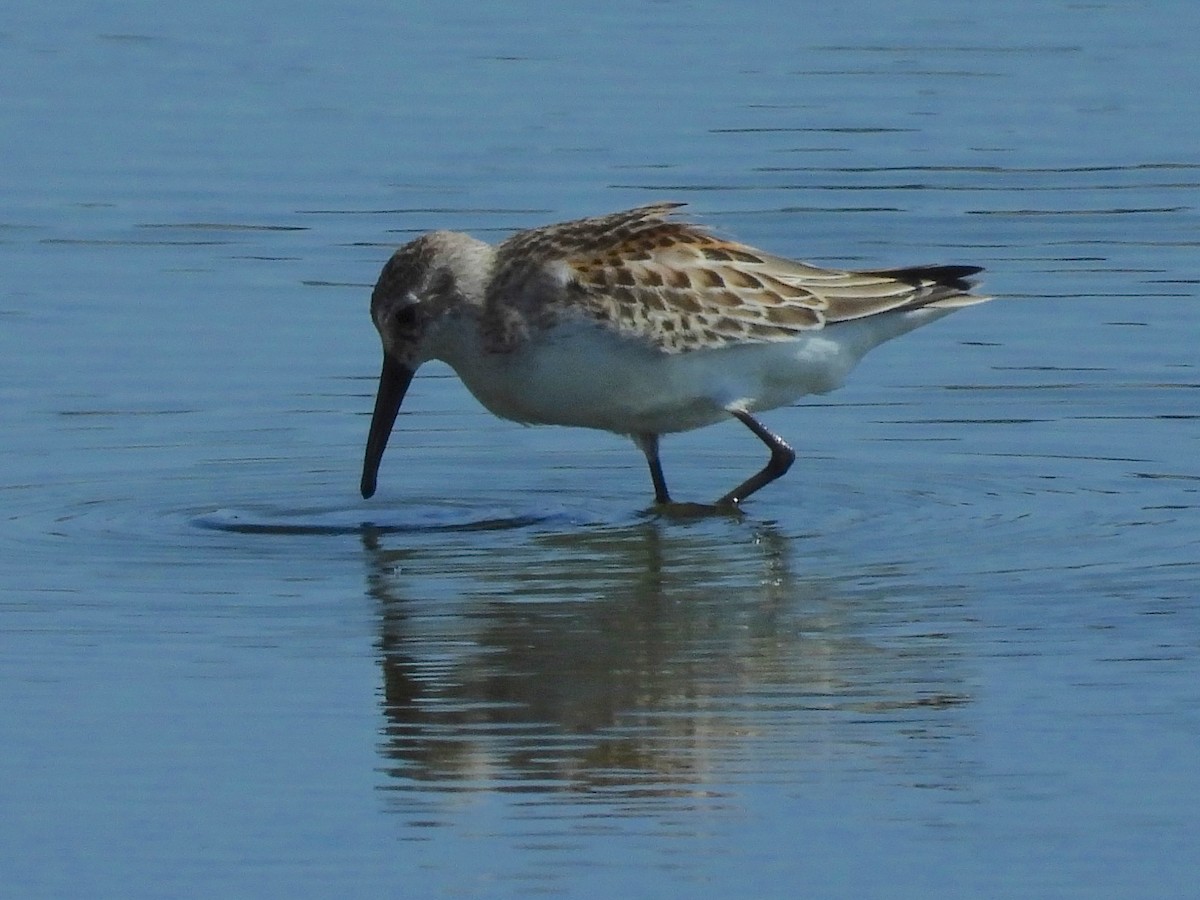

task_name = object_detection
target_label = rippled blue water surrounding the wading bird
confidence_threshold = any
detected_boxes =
[0,0,1200,898]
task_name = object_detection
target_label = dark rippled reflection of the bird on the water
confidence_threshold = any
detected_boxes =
[364,520,961,798]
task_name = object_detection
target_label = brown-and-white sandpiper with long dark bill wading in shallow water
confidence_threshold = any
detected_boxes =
[361,203,990,508]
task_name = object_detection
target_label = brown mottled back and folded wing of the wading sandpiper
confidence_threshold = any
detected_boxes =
[485,203,985,353]
